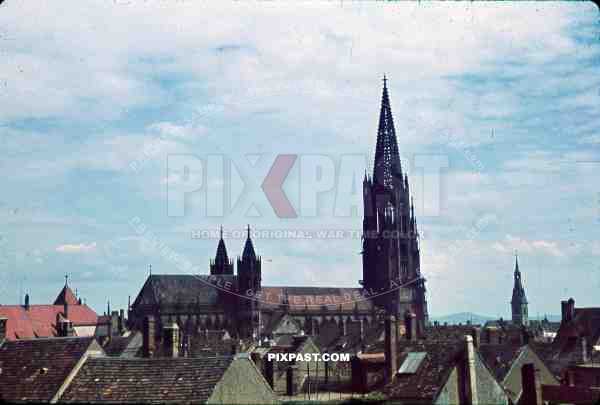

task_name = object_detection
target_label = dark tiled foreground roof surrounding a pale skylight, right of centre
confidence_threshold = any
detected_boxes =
[383,342,464,401]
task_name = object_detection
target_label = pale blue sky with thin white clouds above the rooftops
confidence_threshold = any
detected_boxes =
[0,0,600,317]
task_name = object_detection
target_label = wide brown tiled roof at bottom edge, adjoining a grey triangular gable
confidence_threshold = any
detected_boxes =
[60,356,233,404]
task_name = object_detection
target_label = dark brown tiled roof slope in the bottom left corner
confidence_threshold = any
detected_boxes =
[0,338,94,402]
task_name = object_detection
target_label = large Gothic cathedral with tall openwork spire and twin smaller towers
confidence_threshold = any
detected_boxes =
[129,78,428,347]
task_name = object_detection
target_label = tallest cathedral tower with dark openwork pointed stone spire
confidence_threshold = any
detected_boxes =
[362,76,428,331]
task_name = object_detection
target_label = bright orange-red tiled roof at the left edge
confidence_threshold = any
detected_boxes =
[0,305,98,340]
